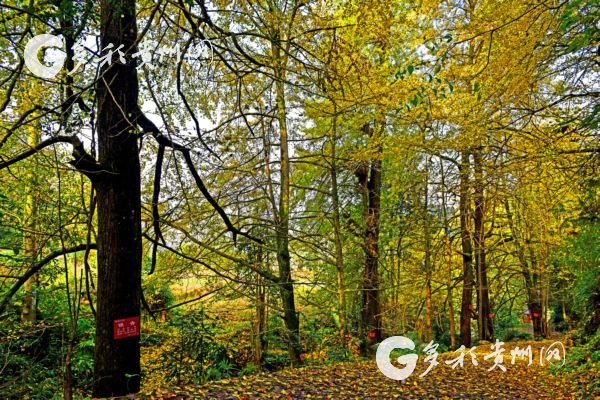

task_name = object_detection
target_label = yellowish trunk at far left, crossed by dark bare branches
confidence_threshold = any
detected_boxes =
[21,127,39,322]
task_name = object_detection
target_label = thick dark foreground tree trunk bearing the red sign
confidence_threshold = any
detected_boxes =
[93,0,142,397]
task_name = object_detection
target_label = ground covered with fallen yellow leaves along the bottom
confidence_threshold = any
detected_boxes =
[140,341,600,400]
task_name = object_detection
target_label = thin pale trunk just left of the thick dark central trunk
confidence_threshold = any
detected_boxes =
[330,107,347,346]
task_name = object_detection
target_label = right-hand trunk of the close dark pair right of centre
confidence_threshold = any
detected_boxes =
[473,148,493,341]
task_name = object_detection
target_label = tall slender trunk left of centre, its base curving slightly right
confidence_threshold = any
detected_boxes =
[272,42,302,366]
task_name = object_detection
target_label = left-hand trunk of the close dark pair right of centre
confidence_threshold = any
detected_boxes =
[459,151,473,347]
